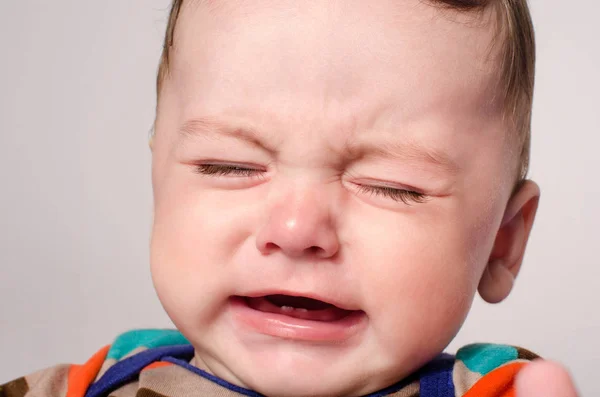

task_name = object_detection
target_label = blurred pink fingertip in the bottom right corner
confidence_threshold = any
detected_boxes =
[516,360,577,397]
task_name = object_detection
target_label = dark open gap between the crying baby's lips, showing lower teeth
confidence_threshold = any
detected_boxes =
[243,295,353,322]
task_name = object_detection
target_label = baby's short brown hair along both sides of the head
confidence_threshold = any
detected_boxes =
[156,0,535,183]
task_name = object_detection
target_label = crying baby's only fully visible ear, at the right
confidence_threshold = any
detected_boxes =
[479,180,540,303]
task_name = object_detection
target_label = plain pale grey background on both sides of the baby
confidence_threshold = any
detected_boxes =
[0,0,600,396]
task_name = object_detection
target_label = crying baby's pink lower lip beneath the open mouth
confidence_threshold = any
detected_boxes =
[230,297,366,343]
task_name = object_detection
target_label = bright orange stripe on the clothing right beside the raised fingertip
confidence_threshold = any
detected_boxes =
[463,363,526,397]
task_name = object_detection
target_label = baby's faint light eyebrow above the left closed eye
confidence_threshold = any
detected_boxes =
[179,116,275,152]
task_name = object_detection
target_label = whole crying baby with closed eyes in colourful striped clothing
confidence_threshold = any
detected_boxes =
[0,0,575,397]
